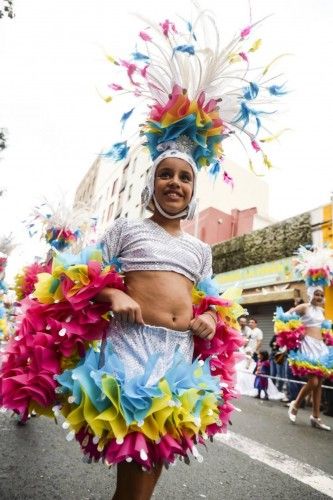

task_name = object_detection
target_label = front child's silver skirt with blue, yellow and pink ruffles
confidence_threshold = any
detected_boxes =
[56,322,224,469]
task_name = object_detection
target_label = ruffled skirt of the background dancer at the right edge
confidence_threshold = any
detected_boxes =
[288,335,333,380]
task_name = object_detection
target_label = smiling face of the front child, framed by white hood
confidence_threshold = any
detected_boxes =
[154,158,194,215]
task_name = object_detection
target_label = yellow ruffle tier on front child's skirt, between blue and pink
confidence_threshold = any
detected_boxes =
[62,375,219,446]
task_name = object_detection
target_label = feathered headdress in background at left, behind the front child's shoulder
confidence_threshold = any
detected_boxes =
[23,200,96,251]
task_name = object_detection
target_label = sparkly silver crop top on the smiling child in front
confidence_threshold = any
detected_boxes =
[102,218,212,283]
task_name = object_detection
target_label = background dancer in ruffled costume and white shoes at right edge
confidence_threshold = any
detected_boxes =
[275,247,333,431]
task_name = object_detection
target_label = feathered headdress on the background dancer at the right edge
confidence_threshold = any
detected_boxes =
[294,246,333,287]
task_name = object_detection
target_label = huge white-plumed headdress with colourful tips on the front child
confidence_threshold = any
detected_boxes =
[104,0,286,181]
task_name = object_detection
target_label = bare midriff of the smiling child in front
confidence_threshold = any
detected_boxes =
[125,271,193,331]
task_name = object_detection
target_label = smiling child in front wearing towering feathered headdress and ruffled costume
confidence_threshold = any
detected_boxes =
[0,4,285,499]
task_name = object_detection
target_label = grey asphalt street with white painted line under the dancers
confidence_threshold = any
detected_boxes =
[0,397,333,500]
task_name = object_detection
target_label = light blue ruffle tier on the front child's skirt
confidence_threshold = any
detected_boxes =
[56,339,221,424]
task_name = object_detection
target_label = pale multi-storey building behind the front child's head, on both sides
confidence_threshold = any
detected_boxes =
[75,153,273,234]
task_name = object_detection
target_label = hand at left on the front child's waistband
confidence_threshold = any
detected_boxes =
[103,288,144,325]
